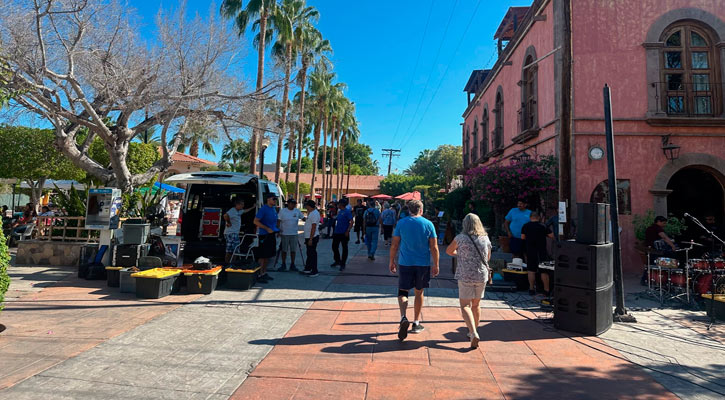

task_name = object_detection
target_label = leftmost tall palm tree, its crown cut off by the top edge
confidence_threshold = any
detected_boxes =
[221,0,277,174]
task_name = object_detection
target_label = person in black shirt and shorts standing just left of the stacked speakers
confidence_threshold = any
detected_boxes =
[521,211,554,297]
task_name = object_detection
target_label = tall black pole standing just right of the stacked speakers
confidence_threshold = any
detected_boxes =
[604,84,627,316]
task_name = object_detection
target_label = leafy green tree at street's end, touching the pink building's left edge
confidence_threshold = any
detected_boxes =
[405,144,463,189]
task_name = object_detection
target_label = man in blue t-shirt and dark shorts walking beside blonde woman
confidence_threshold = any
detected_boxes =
[390,200,438,341]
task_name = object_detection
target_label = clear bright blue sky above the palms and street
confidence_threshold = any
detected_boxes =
[130,0,516,174]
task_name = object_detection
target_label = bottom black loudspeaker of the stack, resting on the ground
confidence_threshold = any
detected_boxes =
[554,283,614,336]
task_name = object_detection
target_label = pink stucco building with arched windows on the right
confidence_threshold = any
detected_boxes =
[462,0,725,272]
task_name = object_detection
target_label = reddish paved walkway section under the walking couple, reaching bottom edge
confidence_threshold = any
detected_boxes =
[232,302,676,400]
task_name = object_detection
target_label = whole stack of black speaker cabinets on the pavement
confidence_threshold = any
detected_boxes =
[554,203,614,335]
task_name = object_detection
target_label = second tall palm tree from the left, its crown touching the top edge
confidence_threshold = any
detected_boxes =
[271,0,319,182]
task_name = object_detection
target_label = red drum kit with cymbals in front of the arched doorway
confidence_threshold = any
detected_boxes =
[647,241,725,304]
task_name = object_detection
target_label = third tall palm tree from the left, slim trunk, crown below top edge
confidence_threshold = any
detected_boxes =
[295,20,332,199]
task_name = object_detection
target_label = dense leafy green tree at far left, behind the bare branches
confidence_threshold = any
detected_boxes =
[0,126,86,205]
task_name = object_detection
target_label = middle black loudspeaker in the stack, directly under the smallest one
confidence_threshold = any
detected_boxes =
[554,241,614,289]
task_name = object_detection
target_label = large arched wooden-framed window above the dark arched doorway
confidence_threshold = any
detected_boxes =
[660,22,720,116]
